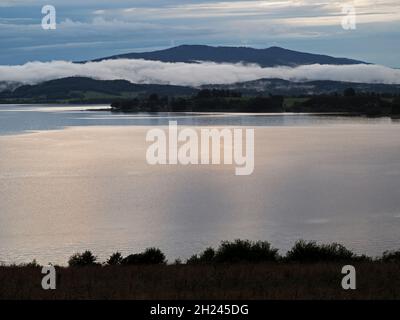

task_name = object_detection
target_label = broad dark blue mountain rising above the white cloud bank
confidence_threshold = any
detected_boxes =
[93,45,365,67]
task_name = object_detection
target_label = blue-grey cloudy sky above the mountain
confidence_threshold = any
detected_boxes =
[0,0,400,68]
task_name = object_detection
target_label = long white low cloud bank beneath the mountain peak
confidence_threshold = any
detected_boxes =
[0,59,400,86]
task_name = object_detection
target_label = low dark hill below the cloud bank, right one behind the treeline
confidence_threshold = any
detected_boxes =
[202,79,400,96]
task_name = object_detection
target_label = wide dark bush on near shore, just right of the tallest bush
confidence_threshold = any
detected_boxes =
[285,240,356,262]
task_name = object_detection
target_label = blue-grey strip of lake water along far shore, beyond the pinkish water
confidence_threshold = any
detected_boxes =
[0,105,393,135]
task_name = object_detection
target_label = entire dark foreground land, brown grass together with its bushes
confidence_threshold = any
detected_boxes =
[0,240,400,299]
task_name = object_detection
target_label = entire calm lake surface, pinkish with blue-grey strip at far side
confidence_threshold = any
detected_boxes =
[0,105,400,264]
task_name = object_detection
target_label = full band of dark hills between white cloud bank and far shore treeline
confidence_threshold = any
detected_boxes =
[0,77,400,103]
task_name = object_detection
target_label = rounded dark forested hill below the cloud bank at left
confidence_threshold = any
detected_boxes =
[0,77,197,103]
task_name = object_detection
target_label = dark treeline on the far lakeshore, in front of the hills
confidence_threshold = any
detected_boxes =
[111,88,400,116]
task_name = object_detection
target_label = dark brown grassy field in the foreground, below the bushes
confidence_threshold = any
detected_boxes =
[0,262,400,300]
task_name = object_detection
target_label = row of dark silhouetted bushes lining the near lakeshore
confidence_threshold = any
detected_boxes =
[7,239,400,267]
